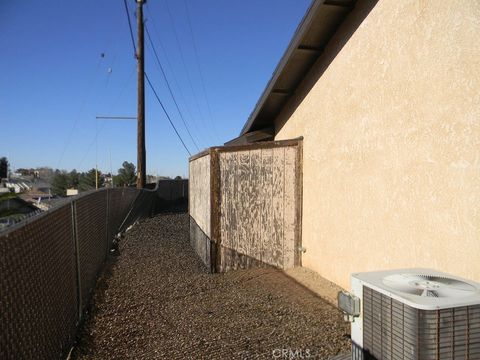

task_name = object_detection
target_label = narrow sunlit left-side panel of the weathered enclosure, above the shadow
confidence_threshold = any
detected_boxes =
[189,155,211,237]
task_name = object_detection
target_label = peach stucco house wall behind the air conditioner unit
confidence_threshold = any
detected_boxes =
[276,0,480,288]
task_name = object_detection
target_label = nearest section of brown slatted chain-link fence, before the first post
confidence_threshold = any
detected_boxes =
[0,204,77,359]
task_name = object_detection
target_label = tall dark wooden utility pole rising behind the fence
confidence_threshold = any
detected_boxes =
[136,0,147,189]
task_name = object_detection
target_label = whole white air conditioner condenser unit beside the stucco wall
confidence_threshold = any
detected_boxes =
[338,269,480,360]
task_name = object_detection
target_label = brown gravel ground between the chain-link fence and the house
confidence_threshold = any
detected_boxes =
[72,214,350,359]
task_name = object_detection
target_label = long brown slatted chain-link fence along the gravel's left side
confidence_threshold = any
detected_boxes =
[0,180,188,359]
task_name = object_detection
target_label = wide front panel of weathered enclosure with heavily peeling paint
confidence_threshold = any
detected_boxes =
[219,146,299,271]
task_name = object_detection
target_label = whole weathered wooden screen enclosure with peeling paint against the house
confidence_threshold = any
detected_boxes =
[190,140,302,271]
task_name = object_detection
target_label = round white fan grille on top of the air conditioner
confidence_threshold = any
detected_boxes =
[383,274,476,298]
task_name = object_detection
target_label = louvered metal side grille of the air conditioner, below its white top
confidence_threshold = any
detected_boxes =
[362,286,480,360]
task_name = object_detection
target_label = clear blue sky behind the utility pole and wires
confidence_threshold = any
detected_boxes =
[0,0,310,176]
